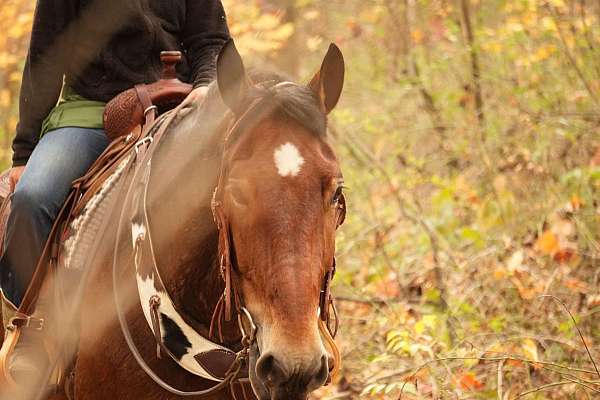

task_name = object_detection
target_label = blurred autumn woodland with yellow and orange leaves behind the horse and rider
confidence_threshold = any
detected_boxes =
[0,0,600,400]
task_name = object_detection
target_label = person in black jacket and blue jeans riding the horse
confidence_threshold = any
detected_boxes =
[0,0,229,388]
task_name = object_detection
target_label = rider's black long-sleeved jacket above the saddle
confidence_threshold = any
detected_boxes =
[13,0,229,166]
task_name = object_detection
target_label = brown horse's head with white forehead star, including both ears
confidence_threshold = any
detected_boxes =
[213,42,345,400]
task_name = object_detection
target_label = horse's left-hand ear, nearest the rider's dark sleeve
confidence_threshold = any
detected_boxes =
[217,39,250,111]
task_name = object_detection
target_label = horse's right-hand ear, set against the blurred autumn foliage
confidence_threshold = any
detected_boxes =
[308,43,345,114]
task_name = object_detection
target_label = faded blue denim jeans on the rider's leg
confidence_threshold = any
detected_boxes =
[0,127,109,307]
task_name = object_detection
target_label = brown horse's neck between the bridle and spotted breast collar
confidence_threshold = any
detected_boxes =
[148,90,231,330]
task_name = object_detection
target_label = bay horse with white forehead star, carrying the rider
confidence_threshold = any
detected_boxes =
[16,42,345,400]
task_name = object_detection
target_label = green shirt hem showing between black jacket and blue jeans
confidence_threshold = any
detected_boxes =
[40,85,106,137]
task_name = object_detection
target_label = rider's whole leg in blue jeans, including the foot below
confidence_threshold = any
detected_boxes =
[0,128,108,394]
